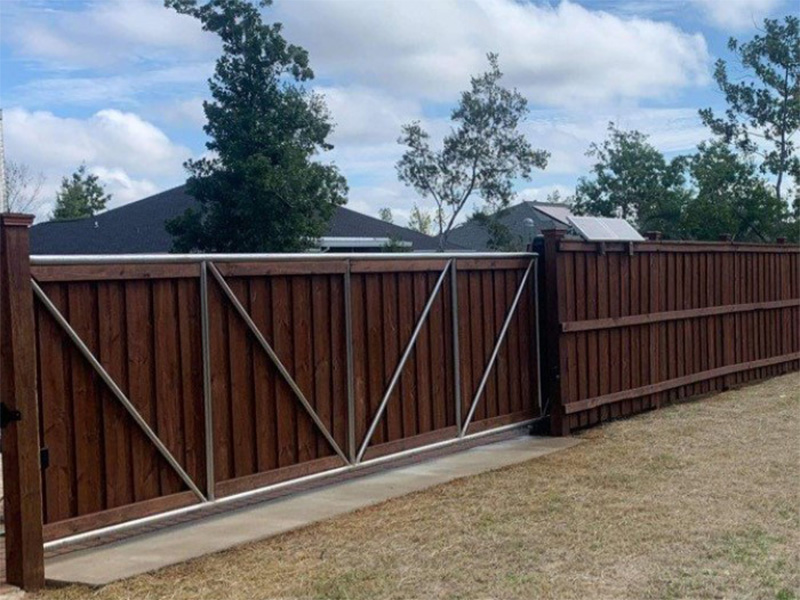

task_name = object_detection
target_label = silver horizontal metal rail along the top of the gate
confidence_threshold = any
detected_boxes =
[31,252,536,266]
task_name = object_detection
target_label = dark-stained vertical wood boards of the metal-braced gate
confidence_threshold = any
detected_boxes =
[25,255,540,540]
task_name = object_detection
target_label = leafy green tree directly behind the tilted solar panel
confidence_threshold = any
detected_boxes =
[571,123,687,237]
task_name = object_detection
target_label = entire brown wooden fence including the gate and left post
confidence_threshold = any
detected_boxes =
[0,215,800,589]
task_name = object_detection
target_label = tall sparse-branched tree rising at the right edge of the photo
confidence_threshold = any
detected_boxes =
[700,16,800,200]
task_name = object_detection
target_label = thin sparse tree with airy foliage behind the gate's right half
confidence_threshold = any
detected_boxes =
[397,54,549,251]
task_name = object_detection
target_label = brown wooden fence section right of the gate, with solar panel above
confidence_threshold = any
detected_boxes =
[540,231,800,434]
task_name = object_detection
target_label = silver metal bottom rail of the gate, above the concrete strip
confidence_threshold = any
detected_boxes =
[44,417,541,550]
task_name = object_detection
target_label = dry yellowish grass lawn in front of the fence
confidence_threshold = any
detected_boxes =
[40,374,800,600]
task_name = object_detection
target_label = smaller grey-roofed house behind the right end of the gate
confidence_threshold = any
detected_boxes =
[448,201,571,251]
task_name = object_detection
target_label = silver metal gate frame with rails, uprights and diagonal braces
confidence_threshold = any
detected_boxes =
[31,252,542,550]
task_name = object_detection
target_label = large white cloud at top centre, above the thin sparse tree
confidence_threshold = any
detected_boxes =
[275,0,708,105]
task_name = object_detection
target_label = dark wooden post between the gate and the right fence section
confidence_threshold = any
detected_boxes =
[539,229,569,436]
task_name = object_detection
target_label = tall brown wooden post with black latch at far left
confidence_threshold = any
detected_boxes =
[0,214,44,591]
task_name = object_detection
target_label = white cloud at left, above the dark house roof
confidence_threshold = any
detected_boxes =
[3,108,191,217]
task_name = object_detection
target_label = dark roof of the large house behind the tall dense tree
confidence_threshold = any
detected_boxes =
[31,186,458,254]
